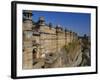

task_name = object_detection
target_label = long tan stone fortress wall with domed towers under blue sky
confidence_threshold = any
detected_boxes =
[23,10,78,69]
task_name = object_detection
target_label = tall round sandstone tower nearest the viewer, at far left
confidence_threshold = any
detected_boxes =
[23,10,33,69]
